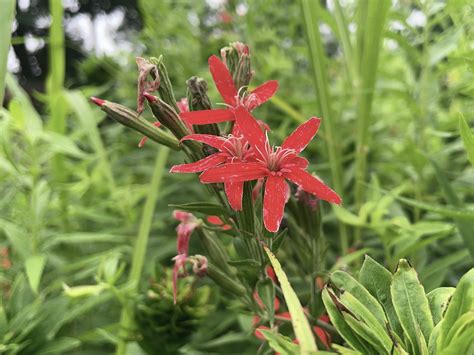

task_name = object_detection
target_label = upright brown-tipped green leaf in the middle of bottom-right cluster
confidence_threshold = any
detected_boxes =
[391,259,433,354]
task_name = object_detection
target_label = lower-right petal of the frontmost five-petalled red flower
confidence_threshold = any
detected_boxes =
[284,167,342,205]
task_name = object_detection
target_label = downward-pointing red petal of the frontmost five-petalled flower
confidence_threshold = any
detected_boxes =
[263,176,288,233]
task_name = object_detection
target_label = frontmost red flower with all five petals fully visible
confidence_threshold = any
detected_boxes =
[200,107,341,232]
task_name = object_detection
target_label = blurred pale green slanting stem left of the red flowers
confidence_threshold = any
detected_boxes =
[116,147,169,355]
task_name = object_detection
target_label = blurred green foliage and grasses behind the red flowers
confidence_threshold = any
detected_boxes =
[0,0,474,354]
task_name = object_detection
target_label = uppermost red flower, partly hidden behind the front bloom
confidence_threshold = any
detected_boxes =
[180,55,278,125]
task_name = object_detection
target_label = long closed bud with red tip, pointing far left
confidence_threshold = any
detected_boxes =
[91,97,180,150]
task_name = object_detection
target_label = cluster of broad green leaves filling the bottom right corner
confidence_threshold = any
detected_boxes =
[323,256,474,354]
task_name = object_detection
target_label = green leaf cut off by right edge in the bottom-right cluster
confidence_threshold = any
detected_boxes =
[438,269,474,350]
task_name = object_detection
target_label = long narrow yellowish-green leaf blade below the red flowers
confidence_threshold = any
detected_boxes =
[263,246,317,354]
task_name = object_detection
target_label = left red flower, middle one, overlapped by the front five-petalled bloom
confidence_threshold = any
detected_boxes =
[170,133,256,211]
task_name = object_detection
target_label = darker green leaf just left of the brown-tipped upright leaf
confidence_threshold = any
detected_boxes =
[359,255,403,337]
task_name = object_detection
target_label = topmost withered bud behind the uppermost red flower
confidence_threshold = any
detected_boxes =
[221,42,253,88]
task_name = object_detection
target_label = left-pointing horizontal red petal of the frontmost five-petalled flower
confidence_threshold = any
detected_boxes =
[200,163,268,184]
